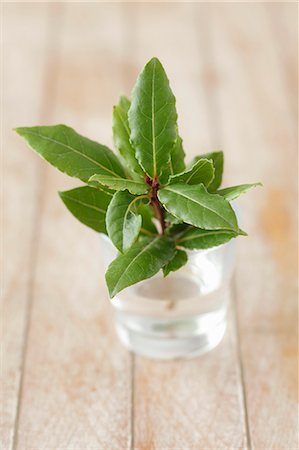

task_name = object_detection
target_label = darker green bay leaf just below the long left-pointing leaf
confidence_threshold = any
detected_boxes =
[59,186,112,233]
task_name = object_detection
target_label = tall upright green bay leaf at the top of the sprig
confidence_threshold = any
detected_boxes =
[128,58,177,178]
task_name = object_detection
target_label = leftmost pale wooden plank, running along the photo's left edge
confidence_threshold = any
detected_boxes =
[0,4,56,450]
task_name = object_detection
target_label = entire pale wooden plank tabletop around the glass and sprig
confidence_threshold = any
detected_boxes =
[0,2,298,450]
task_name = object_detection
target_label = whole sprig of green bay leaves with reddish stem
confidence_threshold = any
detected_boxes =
[16,58,260,298]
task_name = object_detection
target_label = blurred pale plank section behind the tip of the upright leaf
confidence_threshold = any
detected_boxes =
[126,3,214,160]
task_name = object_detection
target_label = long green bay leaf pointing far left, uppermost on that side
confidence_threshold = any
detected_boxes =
[16,125,125,182]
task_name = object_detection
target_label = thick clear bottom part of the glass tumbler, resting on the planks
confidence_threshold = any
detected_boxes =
[116,308,227,359]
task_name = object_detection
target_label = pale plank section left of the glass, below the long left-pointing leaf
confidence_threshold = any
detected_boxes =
[14,171,131,449]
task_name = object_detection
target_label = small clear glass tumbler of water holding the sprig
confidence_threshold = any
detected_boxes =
[101,235,235,359]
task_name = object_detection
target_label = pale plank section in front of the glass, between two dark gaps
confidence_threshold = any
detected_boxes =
[134,325,246,450]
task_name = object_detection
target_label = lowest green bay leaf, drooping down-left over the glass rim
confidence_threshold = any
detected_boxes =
[106,236,175,298]
